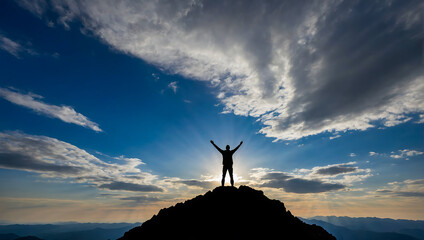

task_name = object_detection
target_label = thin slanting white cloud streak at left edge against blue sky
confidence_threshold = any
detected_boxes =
[0,88,102,132]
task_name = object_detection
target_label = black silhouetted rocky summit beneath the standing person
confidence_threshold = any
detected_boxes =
[120,186,336,240]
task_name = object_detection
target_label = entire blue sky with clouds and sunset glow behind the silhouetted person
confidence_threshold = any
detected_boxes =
[0,0,424,222]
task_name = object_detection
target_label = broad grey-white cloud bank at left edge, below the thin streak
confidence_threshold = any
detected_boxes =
[0,132,163,192]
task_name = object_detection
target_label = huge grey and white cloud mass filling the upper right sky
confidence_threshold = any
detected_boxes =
[22,0,424,140]
